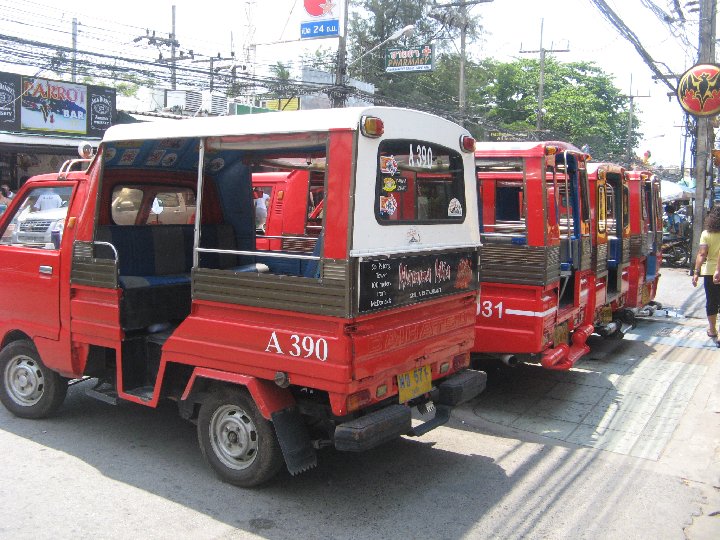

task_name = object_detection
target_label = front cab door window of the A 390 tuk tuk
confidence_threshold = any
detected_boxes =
[0,187,72,249]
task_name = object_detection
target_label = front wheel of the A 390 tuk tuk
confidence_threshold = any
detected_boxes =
[0,340,68,418]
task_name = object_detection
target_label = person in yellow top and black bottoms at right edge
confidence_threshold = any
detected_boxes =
[692,206,720,339]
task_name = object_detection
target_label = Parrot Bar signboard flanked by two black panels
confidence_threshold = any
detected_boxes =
[0,73,116,137]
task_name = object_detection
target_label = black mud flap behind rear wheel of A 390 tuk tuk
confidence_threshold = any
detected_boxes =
[272,407,317,476]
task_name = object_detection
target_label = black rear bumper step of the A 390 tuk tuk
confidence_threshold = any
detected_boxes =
[335,369,487,452]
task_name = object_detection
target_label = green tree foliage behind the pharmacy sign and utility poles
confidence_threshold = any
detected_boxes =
[348,0,640,163]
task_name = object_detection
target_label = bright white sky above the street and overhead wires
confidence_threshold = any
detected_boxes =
[0,0,698,166]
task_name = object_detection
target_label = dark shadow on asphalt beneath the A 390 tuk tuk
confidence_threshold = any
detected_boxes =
[0,383,513,539]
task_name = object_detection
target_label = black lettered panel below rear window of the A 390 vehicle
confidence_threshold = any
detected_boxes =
[359,251,477,313]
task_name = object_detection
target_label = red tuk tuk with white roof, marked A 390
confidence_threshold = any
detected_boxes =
[0,107,485,486]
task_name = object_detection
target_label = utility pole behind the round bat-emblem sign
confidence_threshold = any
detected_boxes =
[693,0,717,254]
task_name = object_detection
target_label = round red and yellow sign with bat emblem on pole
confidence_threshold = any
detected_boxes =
[677,64,720,116]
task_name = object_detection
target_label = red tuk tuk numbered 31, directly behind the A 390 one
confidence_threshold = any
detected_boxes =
[473,142,593,370]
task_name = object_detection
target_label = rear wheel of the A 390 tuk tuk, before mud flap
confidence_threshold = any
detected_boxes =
[197,390,284,487]
